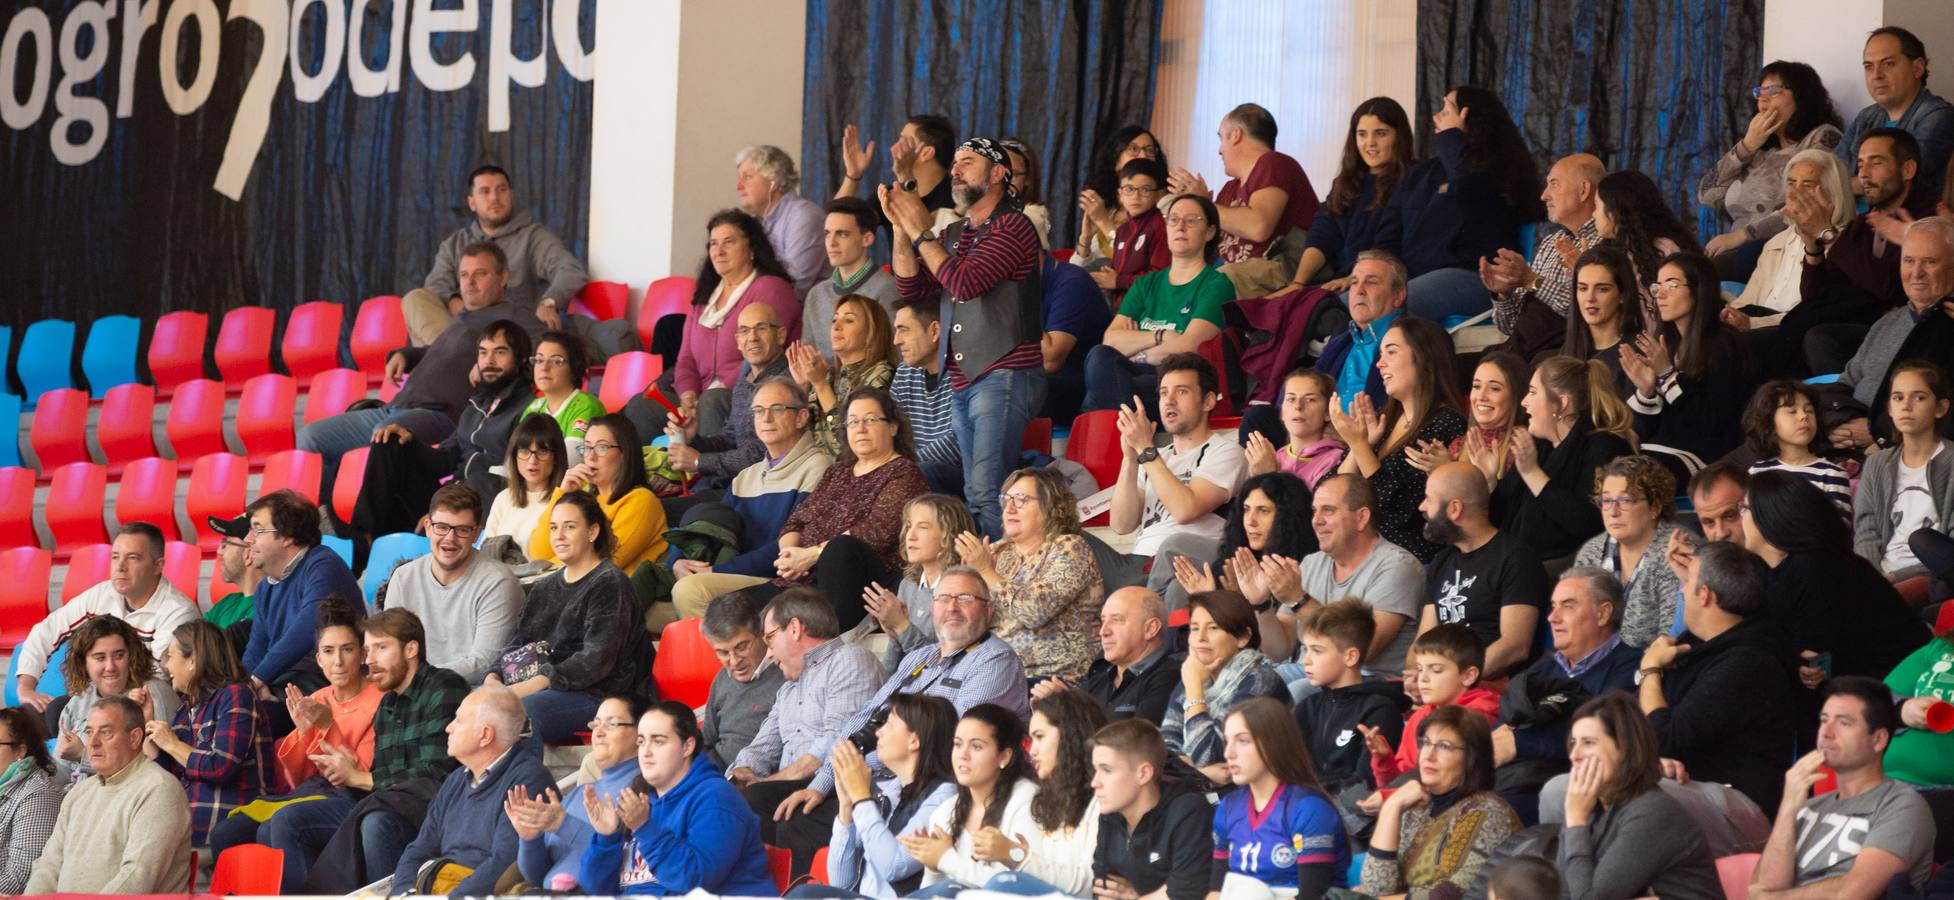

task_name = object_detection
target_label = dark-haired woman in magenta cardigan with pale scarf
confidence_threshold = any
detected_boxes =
[668,209,801,433]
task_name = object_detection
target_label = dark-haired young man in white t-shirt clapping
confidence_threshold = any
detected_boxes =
[1108,353,1247,607]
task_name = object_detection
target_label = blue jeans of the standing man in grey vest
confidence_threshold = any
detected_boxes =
[950,369,1045,541]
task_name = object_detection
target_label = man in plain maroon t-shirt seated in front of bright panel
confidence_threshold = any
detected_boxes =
[1167,103,1317,297]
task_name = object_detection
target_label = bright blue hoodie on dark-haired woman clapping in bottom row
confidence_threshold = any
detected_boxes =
[576,754,780,896]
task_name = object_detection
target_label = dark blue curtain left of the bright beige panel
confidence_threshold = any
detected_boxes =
[801,0,1161,246]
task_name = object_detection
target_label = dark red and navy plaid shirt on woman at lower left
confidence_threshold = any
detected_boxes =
[156,681,274,845]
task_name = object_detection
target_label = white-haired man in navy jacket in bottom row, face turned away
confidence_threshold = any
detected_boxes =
[391,685,557,896]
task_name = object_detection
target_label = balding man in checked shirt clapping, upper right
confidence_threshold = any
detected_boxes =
[1479,152,1608,346]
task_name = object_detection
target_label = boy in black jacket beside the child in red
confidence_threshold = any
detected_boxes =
[1296,597,1407,797]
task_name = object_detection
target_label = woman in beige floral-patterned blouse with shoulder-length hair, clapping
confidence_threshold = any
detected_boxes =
[957,469,1106,679]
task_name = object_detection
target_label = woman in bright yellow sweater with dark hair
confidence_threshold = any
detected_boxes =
[530,412,666,574]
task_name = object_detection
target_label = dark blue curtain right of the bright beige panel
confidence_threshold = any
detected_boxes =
[1417,0,1764,238]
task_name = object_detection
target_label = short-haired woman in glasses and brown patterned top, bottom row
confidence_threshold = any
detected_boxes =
[1358,707,1520,900]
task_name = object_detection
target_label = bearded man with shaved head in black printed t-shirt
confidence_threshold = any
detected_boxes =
[1419,463,1548,679]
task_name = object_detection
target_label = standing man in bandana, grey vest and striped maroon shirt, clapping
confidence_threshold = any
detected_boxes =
[879,137,1045,539]
